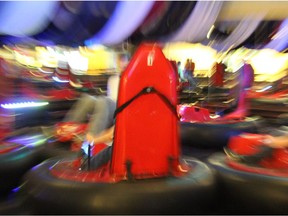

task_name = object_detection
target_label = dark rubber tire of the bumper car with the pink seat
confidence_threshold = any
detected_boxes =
[180,117,265,149]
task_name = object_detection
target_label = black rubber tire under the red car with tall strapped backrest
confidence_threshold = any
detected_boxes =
[20,158,216,214]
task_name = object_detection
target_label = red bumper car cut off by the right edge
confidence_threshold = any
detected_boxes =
[208,129,288,214]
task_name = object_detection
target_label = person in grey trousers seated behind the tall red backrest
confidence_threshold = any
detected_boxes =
[56,75,120,169]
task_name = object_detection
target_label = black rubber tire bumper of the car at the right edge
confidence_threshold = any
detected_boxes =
[208,153,288,215]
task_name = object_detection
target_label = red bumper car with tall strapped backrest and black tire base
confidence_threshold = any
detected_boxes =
[20,44,215,214]
